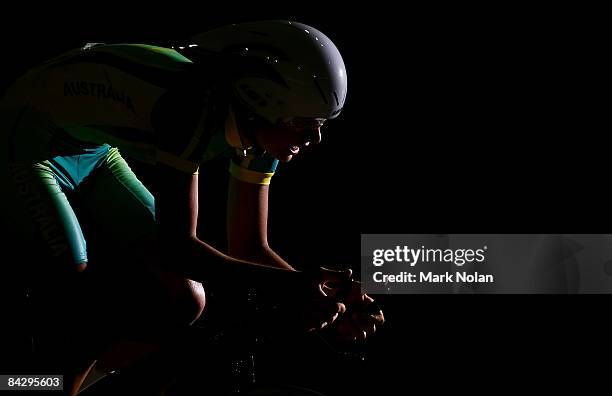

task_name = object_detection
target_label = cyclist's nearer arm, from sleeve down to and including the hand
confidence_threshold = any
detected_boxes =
[156,165,350,330]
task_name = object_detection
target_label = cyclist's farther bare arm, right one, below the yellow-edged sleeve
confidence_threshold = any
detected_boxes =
[227,176,293,270]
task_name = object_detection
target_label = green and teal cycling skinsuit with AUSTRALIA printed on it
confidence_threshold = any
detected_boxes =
[0,44,278,270]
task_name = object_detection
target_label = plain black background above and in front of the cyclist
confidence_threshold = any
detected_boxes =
[2,3,611,394]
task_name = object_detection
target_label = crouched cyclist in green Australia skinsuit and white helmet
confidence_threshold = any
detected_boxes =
[0,21,383,389]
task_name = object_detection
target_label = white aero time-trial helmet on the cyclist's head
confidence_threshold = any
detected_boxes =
[192,21,347,123]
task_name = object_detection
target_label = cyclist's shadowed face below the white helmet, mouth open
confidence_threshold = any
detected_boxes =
[255,118,325,162]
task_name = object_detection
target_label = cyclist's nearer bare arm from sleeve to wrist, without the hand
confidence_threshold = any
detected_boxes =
[155,164,301,285]
